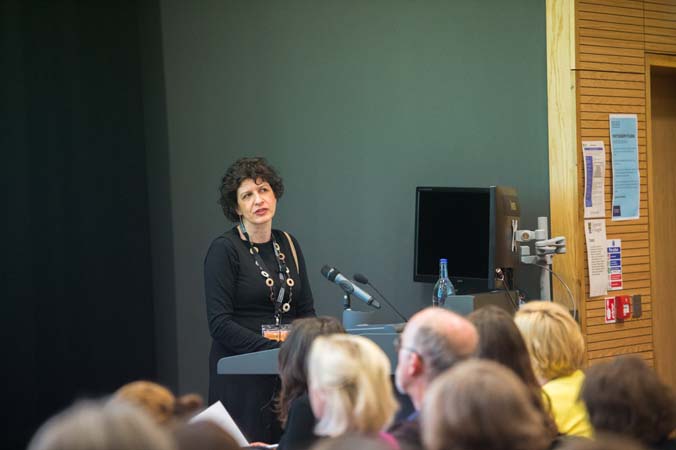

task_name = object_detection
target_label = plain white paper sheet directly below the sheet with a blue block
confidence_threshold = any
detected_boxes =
[584,219,608,297]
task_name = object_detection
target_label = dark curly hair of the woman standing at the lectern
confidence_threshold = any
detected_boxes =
[218,157,284,222]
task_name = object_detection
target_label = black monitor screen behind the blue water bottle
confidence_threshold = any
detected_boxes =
[413,187,495,294]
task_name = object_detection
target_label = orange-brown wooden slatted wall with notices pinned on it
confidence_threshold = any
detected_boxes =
[575,0,676,364]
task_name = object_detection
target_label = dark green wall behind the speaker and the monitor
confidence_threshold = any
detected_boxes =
[156,0,549,391]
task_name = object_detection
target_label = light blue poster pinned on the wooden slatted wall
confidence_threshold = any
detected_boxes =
[610,114,641,220]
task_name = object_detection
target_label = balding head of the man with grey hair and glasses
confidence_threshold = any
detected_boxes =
[395,308,479,410]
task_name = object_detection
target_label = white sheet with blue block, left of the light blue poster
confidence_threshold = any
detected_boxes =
[582,141,606,219]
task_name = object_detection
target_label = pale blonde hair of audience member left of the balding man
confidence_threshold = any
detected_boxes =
[308,334,399,436]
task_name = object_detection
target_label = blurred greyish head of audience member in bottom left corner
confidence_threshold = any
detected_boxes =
[28,401,175,450]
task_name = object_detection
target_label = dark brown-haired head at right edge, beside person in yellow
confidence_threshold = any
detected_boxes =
[582,356,676,445]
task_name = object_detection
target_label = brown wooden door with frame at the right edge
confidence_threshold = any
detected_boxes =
[646,54,676,387]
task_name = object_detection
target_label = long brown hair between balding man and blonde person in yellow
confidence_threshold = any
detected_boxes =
[467,305,558,437]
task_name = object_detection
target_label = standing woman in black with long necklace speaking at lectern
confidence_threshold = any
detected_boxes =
[204,158,315,442]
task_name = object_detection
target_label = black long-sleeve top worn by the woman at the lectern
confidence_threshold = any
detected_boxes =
[204,227,315,358]
